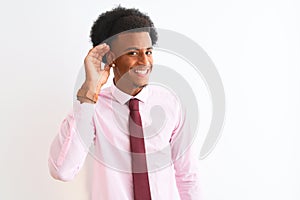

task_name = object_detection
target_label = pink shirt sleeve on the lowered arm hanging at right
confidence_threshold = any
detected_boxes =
[170,105,202,200]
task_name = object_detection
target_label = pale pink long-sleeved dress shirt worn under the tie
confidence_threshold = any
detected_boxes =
[49,85,201,200]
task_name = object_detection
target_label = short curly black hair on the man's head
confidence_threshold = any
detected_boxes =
[90,6,157,62]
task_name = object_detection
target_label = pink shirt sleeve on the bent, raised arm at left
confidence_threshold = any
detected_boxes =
[48,102,95,181]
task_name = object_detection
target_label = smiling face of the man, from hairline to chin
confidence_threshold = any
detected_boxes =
[111,32,153,93]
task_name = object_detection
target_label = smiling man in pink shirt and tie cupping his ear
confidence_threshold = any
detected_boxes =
[49,7,200,200]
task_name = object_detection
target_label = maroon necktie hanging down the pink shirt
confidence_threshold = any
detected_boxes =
[129,99,151,200]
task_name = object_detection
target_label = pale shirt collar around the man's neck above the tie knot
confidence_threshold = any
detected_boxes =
[111,84,149,105]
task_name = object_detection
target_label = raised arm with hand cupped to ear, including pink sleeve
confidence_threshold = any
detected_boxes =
[48,44,110,181]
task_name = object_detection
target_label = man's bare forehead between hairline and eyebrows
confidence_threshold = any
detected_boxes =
[111,32,152,53]
